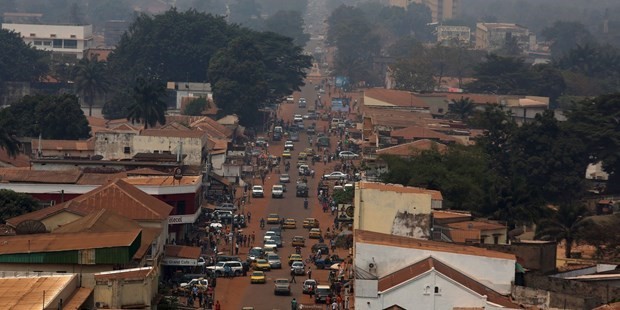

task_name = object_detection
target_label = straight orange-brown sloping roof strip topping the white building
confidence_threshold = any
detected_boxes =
[354,230,516,261]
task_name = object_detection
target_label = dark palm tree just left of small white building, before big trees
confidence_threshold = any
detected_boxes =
[127,77,166,129]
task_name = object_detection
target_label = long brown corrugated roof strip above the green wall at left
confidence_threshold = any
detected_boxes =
[0,229,140,255]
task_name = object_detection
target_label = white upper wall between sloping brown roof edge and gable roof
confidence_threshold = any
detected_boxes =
[354,242,515,294]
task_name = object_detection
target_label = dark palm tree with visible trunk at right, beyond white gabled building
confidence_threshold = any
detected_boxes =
[535,204,588,258]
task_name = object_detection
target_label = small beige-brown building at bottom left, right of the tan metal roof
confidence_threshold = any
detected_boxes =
[94,267,158,309]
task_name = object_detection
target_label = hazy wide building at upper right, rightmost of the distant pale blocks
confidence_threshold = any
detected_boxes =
[475,23,530,52]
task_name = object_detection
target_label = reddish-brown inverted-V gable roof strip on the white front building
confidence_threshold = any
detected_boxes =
[378,257,519,308]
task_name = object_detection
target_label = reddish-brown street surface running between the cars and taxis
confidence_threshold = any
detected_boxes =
[215,81,348,309]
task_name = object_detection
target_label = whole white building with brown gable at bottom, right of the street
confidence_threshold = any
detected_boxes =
[354,230,519,310]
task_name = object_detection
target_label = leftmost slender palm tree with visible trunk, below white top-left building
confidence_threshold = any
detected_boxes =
[74,58,110,116]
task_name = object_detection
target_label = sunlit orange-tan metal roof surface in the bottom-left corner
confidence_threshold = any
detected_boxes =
[0,275,75,310]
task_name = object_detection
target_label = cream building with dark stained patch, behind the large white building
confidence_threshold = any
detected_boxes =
[353,182,443,239]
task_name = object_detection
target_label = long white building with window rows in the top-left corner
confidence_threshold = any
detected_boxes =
[2,24,94,59]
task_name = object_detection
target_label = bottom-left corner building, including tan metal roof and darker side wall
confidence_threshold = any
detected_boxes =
[0,272,94,310]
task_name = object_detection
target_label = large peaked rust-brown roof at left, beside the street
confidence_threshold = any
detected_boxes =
[6,179,172,227]
